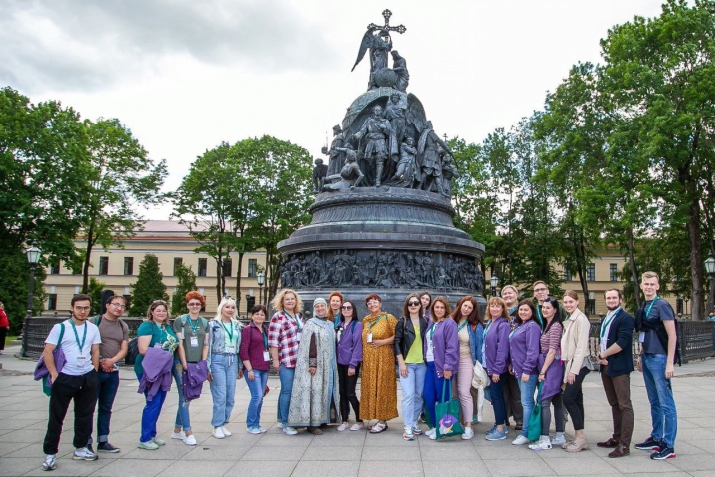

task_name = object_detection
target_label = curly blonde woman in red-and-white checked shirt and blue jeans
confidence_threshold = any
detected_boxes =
[268,288,305,436]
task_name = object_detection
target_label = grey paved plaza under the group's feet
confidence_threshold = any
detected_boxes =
[0,347,715,477]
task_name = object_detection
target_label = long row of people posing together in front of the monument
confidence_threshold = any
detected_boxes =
[43,272,677,470]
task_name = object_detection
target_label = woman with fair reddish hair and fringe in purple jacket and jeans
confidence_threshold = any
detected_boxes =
[484,296,511,441]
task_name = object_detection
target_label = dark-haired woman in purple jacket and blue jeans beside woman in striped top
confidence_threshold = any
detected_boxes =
[509,300,541,446]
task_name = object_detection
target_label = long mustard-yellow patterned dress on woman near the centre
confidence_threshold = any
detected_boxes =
[360,313,398,421]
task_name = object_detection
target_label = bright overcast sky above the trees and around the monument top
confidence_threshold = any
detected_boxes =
[0,0,662,219]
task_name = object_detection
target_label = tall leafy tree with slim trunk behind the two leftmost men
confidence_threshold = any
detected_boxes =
[80,118,167,293]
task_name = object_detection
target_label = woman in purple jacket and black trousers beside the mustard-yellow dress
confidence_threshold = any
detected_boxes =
[335,300,365,432]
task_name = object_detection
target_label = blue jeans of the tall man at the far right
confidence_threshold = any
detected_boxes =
[641,353,678,447]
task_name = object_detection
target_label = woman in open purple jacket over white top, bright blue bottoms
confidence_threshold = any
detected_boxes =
[424,296,459,440]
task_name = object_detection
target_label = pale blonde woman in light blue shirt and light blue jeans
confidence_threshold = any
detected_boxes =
[208,297,243,439]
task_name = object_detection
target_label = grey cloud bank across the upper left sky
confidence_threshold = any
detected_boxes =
[0,0,336,92]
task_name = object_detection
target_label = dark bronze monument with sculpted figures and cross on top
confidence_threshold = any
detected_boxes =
[278,10,484,317]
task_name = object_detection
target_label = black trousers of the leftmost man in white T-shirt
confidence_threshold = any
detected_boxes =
[43,369,98,455]
